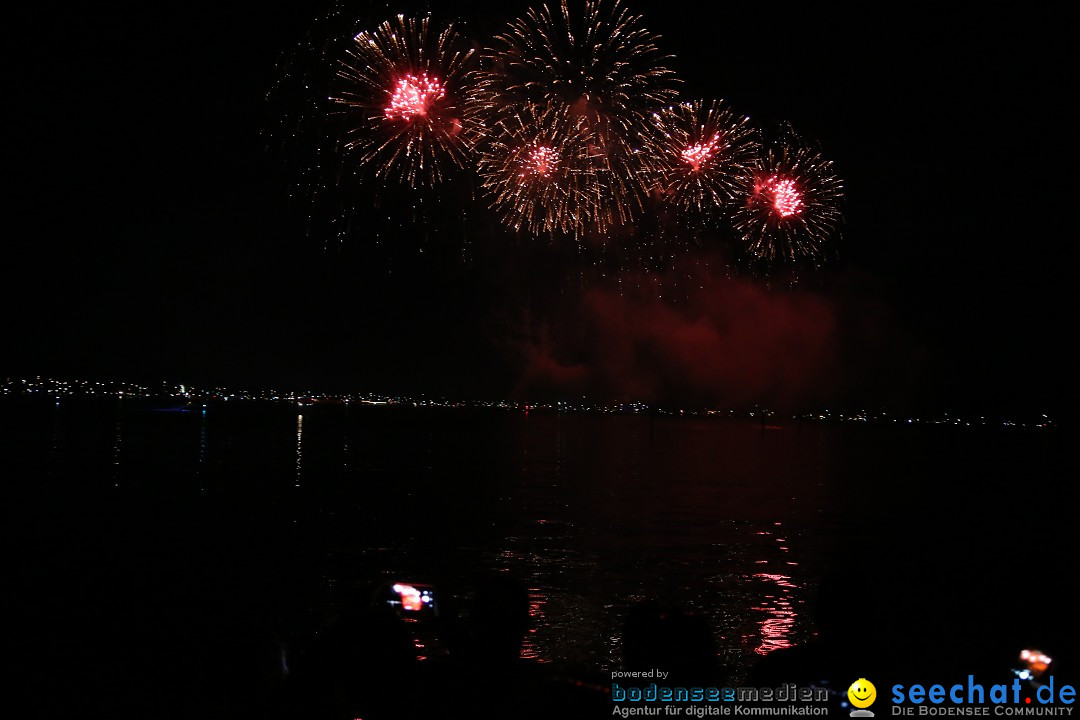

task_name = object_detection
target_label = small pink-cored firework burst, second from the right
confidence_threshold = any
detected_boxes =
[649,100,759,214]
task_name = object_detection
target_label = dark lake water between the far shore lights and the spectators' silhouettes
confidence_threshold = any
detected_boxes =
[6,397,1077,716]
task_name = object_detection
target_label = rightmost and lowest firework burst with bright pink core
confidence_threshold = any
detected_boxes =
[734,132,843,261]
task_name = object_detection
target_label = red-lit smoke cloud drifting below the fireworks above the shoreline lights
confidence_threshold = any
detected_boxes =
[518,272,838,405]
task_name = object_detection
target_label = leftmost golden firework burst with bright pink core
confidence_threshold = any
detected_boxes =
[332,15,473,185]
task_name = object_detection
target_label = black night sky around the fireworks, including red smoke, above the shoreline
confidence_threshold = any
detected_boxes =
[0,0,1076,412]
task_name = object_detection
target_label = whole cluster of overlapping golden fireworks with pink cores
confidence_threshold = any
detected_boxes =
[274,0,842,267]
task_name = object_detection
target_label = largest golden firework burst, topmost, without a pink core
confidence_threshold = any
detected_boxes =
[473,0,675,234]
